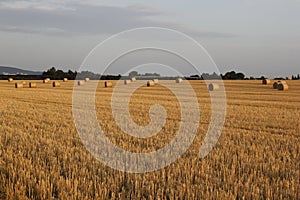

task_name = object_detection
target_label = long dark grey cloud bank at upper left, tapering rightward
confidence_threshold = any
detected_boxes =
[0,1,234,38]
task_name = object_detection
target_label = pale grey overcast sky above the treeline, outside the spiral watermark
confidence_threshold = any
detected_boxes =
[0,0,300,77]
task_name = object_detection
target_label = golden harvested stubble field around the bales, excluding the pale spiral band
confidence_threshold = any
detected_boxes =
[0,80,300,199]
